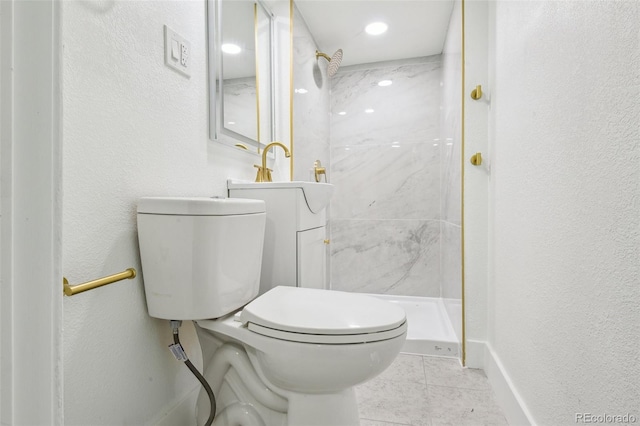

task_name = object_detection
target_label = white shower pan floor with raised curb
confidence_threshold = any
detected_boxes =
[370,294,460,358]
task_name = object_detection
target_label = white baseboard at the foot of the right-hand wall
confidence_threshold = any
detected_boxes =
[466,340,536,426]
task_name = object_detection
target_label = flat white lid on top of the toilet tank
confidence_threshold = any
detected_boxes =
[138,197,265,216]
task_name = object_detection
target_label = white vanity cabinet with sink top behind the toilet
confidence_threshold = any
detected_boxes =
[227,179,333,291]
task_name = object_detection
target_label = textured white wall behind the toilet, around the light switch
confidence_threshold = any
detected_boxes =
[62,1,278,425]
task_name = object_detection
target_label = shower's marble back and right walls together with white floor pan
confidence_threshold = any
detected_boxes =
[330,54,461,357]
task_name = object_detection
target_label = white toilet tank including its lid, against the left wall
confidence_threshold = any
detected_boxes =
[138,197,266,320]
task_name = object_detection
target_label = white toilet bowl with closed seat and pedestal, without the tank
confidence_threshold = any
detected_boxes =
[196,287,407,425]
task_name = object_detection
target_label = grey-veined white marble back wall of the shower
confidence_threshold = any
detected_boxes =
[331,55,441,297]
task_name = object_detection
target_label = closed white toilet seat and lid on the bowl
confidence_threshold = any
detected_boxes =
[239,286,407,344]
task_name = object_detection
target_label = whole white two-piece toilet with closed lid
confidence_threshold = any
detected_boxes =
[138,197,407,426]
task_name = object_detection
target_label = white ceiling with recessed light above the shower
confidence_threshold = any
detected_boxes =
[295,0,453,66]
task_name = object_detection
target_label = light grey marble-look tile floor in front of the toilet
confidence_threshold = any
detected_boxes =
[356,354,508,426]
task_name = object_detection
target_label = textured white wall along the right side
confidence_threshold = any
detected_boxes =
[489,1,640,425]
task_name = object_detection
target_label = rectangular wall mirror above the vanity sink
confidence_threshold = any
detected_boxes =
[207,0,275,154]
